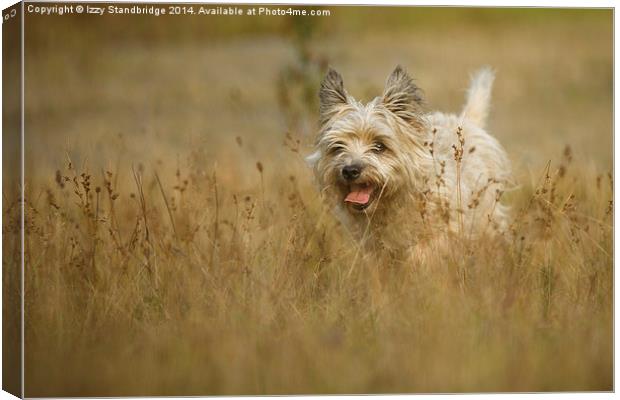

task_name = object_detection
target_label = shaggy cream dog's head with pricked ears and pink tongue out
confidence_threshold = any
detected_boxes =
[308,66,424,214]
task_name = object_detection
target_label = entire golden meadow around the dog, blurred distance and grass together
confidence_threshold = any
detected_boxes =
[3,7,613,396]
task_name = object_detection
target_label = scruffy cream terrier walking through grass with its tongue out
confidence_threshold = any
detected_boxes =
[307,66,512,255]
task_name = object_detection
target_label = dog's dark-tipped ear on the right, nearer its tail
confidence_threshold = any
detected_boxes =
[382,65,423,124]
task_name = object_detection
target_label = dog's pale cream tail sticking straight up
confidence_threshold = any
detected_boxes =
[461,67,495,128]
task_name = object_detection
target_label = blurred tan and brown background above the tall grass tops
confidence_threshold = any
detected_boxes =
[26,6,613,184]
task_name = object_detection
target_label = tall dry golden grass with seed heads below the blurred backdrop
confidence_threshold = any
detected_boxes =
[14,139,612,396]
